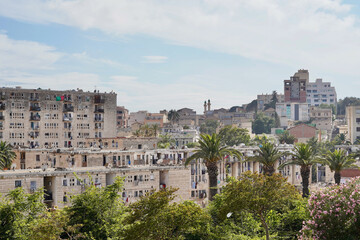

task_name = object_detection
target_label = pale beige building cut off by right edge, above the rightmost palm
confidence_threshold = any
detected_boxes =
[346,106,360,143]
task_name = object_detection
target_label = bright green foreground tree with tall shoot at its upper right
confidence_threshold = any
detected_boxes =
[65,177,124,239]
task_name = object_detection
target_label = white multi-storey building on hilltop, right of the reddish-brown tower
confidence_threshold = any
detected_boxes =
[306,78,337,106]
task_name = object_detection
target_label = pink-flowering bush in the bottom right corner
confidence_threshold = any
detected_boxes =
[299,178,360,240]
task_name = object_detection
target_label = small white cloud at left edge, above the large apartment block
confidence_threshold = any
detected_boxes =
[0,33,63,72]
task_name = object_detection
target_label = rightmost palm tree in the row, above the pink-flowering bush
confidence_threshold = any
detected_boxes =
[320,149,359,185]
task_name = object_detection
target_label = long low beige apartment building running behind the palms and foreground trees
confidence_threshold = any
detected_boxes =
[0,146,316,207]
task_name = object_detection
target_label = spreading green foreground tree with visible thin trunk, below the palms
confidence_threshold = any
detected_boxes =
[214,172,300,239]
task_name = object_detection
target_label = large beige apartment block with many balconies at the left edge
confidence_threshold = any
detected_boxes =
[0,87,116,148]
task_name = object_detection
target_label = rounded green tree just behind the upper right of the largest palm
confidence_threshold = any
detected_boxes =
[219,125,250,146]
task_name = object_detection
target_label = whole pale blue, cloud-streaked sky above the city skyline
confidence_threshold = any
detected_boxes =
[0,0,360,113]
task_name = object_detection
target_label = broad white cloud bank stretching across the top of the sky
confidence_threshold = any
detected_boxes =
[0,0,360,75]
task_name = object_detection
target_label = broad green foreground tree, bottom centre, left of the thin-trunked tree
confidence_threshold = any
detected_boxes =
[123,188,211,240]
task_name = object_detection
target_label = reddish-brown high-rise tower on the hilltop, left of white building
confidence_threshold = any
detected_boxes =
[284,69,309,103]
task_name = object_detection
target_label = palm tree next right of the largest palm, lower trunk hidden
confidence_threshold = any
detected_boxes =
[246,142,286,176]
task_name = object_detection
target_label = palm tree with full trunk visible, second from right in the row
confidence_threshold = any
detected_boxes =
[279,143,317,197]
